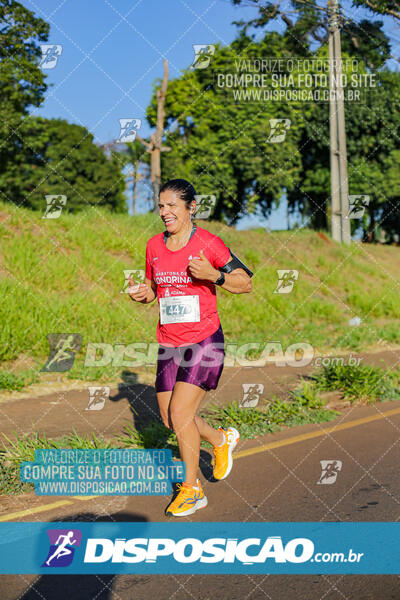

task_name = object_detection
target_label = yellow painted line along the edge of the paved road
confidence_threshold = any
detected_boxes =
[0,408,400,521]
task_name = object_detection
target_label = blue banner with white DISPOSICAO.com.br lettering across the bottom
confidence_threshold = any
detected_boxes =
[0,521,400,575]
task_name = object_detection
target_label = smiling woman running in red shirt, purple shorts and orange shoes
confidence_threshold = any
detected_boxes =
[130,179,252,517]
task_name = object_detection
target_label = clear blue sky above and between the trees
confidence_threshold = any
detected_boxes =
[27,0,393,229]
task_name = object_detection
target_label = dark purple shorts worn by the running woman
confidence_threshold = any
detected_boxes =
[155,325,225,392]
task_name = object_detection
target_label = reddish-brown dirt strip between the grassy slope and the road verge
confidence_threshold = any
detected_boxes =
[0,348,400,438]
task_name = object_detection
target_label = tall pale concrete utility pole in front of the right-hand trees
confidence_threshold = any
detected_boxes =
[328,0,351,244]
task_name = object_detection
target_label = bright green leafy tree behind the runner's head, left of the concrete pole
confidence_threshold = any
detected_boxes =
[147,33,300,223]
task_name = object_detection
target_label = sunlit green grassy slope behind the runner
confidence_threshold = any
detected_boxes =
[0,204,400,376]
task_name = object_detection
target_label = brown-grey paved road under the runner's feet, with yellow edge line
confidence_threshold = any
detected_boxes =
[0,402,400,600]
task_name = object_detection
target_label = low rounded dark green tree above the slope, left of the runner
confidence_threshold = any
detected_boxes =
[0,117,126,212]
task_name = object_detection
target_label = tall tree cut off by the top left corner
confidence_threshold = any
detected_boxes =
[0,0,49,172]
